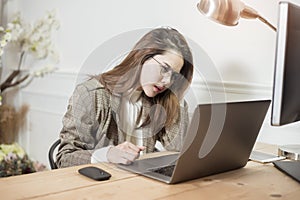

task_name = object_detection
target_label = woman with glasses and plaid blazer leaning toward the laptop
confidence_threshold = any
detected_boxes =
[56,28,193,167]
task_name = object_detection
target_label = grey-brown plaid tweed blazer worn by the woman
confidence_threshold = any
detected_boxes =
[56,78,188,167]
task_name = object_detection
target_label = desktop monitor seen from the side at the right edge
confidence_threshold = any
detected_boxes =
[271,2,300,126]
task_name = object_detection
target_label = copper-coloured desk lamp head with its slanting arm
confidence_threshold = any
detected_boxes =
[197,0,276,31]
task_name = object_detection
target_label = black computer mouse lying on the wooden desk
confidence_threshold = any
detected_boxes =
[78,167,111,181]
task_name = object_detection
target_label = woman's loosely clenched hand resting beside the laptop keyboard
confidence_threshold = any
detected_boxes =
[106,142,145,165]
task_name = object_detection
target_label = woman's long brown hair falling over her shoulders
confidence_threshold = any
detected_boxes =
[96,28,194,127]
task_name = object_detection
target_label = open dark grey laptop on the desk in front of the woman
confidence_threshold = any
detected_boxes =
[118,100,271,184]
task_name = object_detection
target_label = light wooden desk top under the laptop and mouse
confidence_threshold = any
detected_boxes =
[0,144,300,200]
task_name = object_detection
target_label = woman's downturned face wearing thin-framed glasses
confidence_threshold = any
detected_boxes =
[140,51,183,97]
